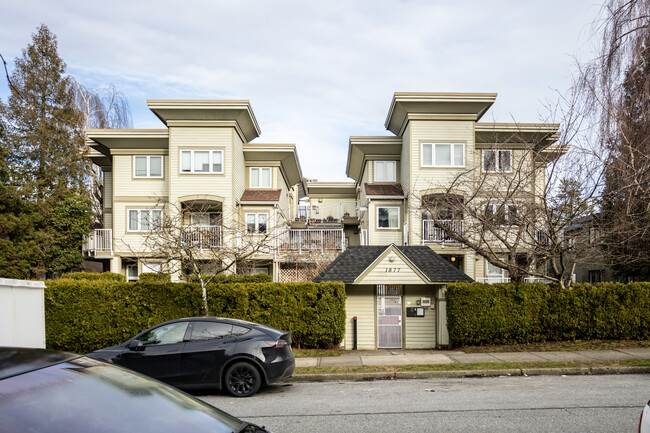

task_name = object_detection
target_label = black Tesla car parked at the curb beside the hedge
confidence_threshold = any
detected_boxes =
[87,317,295,397]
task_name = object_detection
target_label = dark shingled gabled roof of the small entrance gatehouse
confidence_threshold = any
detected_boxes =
[314,244,472,283]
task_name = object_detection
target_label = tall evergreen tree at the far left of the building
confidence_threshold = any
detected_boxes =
[0,25,91,278]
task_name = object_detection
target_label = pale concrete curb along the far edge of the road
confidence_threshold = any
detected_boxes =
[287,366,650,382]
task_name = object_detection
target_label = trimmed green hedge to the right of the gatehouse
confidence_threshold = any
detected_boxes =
[447,283,650,346]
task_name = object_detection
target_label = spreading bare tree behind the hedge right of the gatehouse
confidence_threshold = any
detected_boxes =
[414,115,603,287]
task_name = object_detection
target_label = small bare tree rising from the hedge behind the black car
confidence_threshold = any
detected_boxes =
[123,201,286,316]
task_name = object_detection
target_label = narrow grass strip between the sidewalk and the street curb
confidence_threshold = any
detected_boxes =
[295,359,650,376]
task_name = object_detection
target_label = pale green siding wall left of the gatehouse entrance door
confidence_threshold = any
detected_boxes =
[343,285,377,350]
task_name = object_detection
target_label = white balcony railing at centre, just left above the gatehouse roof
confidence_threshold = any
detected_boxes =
[278,229,345,254]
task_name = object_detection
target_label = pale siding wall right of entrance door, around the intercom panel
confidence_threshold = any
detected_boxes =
[403,286,436,349]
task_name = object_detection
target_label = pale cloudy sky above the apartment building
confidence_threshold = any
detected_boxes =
[0,0,600,181]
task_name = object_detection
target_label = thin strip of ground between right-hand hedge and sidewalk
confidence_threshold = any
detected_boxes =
[454,340,650,353]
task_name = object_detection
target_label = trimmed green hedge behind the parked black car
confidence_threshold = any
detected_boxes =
[45,274,345,353]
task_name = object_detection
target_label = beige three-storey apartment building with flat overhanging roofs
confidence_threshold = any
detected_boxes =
[85,93,561,282]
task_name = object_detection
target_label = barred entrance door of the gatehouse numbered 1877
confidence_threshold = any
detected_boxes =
[377,286,402,349]
